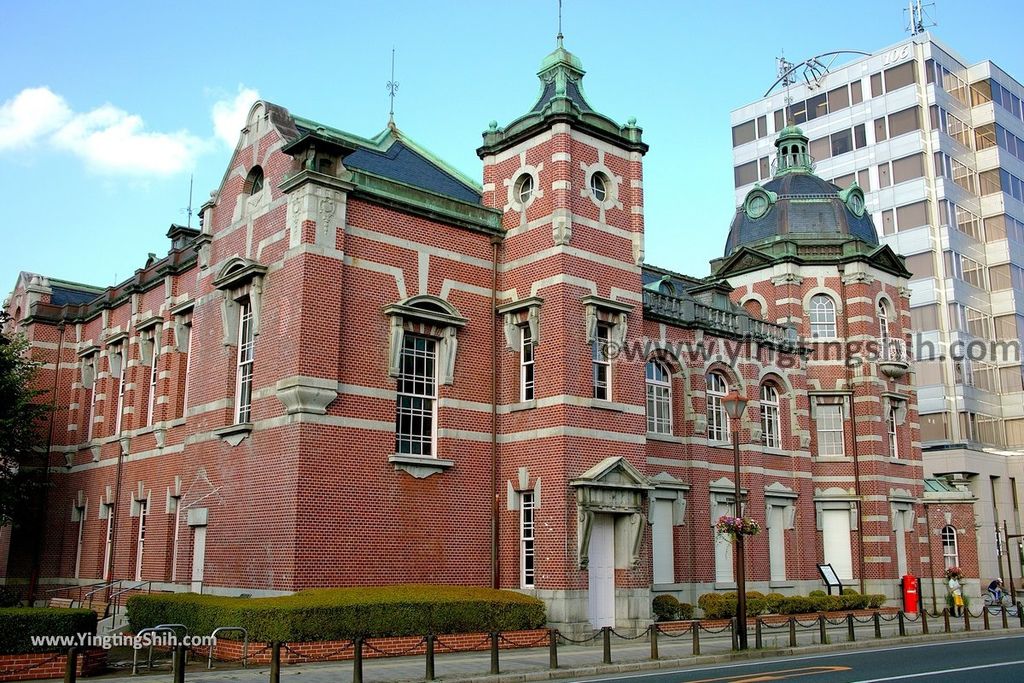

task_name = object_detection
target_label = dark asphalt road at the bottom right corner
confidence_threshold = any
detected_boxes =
[575,635,1024,683]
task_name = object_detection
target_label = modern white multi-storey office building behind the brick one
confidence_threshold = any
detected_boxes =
[732,32,1024,579]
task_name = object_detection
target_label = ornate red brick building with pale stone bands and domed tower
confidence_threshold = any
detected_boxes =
[0,40,975,628]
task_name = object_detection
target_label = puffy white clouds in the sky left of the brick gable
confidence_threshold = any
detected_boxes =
[0,85,259,176]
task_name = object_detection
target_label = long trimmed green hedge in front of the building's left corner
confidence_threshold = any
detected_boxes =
[128,585,546,642]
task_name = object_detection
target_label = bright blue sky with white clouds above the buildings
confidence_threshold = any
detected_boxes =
[0,0,1024,292]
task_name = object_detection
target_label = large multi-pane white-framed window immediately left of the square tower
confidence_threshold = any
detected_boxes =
[394,334,437,458]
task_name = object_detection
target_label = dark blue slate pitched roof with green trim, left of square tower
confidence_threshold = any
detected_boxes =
[293,116,482,204]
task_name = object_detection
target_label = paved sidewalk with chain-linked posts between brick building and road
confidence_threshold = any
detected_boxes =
[74,617,1024,683]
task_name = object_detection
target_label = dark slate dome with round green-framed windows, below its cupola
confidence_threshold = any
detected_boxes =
[725,173,879,256]
